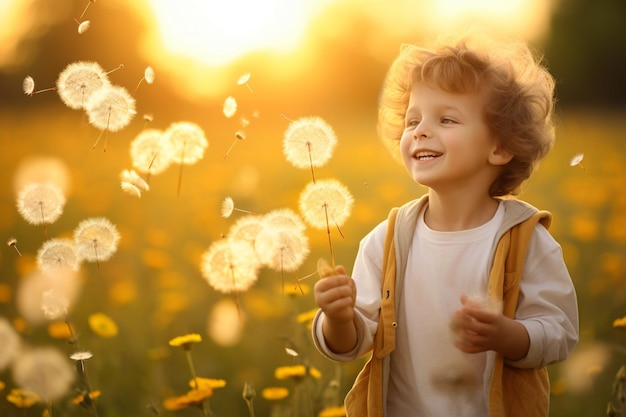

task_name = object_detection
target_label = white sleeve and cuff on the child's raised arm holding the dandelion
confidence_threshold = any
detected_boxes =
[312,220,387,361]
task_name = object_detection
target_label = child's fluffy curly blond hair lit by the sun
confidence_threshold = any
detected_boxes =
[378,34,554,197]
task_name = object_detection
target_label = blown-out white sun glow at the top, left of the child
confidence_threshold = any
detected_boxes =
[149,0,332,66]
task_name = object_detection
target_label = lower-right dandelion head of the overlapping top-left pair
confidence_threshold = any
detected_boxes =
[85,85,137,132]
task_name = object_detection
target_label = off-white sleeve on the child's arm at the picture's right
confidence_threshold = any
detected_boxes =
[507,225,578,368]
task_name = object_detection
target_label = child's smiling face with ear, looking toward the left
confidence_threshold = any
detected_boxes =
[400,83,510,194]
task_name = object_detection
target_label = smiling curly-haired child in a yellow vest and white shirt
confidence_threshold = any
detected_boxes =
[313,35,578,417]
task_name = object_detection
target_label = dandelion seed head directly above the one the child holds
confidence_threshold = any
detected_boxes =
[283,117,337,168]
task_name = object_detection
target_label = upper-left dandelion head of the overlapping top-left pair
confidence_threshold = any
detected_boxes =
[56,61,110,110]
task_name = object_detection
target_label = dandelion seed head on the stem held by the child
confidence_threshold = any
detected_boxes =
[298,179,354,230]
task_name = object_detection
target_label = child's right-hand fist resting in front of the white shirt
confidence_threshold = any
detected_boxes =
[450,295,504,353]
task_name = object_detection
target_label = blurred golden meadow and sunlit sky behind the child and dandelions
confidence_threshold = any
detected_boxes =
[0,0,626,416]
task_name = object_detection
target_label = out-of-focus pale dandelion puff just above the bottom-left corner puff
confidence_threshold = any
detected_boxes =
[15,268,83,326]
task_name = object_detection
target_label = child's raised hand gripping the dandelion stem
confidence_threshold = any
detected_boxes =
[314,266,356,323]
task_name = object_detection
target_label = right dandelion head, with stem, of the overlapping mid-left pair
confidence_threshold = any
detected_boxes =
[165,122,209,195]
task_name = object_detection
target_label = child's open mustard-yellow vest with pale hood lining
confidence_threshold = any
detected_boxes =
[345,196,552,417]
